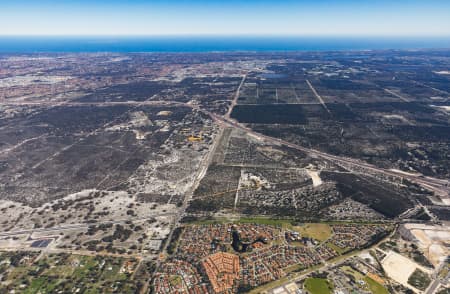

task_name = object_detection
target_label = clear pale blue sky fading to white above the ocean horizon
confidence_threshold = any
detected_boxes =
[0,0,450,36]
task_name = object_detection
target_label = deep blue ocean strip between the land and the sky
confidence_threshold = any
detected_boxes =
[0,36,450,53]
